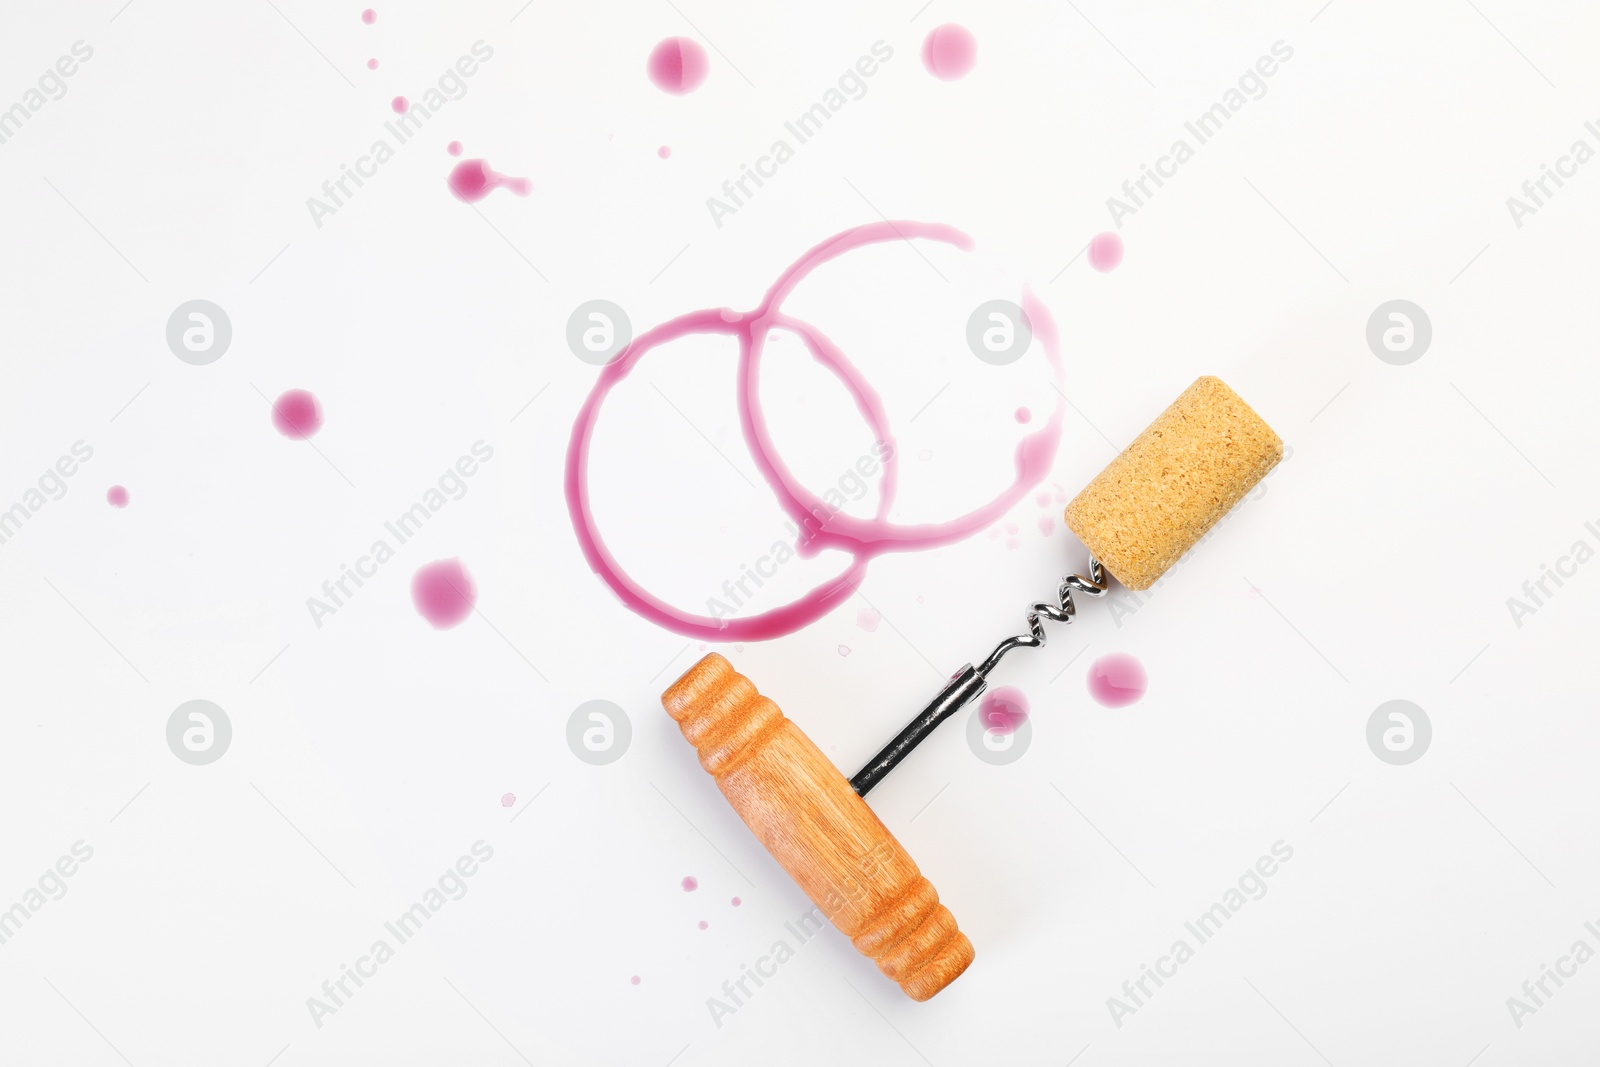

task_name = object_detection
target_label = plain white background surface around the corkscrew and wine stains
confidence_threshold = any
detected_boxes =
[0,0,1600,1067]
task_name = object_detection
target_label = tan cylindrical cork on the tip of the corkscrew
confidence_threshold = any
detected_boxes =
[1067,376,1283,589]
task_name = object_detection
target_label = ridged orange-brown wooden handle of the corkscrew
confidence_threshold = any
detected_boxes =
[661,653,973,1000]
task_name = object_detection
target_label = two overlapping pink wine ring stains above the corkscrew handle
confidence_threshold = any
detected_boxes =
[566,221,1066,643]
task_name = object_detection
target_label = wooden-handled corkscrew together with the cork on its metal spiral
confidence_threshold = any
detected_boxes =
[661,378,1283,1000]
